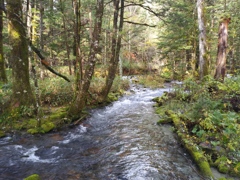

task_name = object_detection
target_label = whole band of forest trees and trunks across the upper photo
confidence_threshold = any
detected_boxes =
[0,0,240,114]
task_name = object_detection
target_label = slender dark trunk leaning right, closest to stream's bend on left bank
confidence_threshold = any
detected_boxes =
[103,0,124,99]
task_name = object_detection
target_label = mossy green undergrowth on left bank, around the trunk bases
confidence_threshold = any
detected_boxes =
[0,67,129,134]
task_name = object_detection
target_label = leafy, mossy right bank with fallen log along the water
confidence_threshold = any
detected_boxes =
[155,76,240,179]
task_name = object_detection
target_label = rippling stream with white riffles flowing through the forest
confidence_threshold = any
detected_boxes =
[0,83,202,180]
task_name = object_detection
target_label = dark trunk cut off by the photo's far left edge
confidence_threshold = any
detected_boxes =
[0,0,7,82]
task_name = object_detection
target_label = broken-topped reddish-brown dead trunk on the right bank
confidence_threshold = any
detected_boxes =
[214,18,231,81]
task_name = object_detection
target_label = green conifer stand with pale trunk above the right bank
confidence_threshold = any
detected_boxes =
[158,0,240,79]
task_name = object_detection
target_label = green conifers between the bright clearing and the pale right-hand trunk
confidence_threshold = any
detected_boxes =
[158,0,199,79]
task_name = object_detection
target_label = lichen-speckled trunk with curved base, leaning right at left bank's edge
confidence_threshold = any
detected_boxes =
[69,0,104,117]
